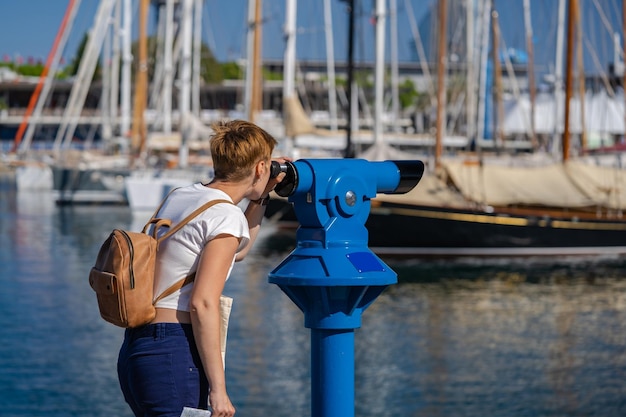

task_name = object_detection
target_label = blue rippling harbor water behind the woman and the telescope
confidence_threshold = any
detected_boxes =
[0,185,626,417]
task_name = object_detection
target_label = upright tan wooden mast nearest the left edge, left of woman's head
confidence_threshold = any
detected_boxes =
[131,0,150,158]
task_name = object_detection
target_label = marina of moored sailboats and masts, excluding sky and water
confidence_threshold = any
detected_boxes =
[0,0,626,257]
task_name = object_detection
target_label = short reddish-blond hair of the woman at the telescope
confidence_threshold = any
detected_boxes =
[210,120,277,181]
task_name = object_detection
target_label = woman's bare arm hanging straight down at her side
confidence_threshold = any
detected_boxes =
[190,235,239,416]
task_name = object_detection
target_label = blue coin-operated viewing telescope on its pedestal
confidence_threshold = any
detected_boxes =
[269,159,424,417]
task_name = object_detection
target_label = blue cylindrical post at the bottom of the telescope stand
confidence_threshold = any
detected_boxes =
[311,329,354,417]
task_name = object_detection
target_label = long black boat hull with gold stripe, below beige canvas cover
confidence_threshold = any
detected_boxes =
[268,200,626,258]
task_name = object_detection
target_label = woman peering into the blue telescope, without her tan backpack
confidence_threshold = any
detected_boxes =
[118,120,284,417]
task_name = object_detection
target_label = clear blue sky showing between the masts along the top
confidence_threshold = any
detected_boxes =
[0,0,622,74]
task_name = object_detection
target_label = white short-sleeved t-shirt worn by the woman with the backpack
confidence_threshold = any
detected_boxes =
[154,183,250,311]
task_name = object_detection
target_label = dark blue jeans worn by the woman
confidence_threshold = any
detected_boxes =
[117,323,209,417]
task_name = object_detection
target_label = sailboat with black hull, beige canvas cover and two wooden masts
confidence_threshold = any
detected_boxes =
[270,0,626,257]
